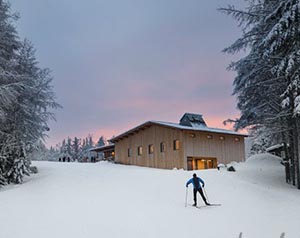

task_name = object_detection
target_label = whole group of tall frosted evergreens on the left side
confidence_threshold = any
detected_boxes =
[0,0,60,186]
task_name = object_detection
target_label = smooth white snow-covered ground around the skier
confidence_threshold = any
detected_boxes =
[0,155,300,238]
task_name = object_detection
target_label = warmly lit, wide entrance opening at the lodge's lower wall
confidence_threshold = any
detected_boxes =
[187,157,218,170]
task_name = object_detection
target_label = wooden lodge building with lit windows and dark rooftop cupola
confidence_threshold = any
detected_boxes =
[104,113,247,170]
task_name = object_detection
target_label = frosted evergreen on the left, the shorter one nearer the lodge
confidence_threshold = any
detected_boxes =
[6,40,59,183]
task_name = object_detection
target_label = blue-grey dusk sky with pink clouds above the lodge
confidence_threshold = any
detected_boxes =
[10,0,243,146]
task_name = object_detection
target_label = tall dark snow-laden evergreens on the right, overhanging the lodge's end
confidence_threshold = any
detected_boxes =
[220,0,300,188]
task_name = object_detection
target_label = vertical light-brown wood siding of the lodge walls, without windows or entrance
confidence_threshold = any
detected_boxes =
[115,125,245,169]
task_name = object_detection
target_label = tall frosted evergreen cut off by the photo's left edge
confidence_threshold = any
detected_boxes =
[0,0,22,185]
